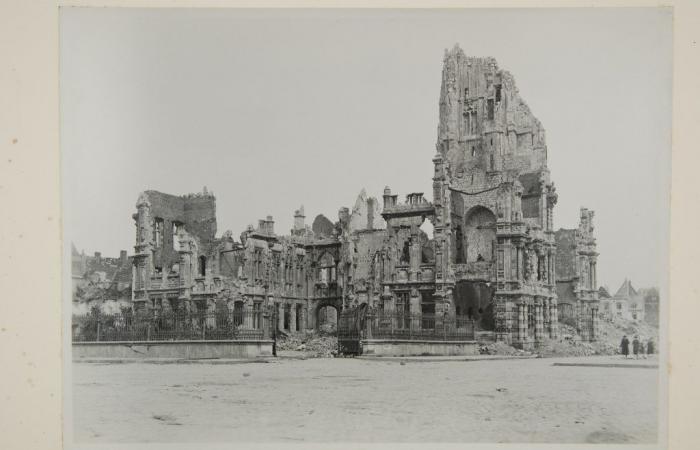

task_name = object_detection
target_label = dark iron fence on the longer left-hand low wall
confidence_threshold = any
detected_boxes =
[72,309,272,342]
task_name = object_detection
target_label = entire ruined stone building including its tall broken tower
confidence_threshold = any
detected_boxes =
[126,47,597,348]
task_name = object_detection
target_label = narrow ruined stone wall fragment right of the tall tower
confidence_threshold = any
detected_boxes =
[555,208,600,340]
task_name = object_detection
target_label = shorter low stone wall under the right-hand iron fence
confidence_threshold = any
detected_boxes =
[361,339,479,356]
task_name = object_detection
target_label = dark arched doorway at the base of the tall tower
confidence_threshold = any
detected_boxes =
[453,281,495,331]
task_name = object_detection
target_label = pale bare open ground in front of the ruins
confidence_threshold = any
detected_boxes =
[73,357,658,443]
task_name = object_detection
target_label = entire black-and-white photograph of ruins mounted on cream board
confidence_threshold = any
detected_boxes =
[59,7,673,448]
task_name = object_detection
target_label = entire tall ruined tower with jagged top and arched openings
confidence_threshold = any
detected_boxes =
[433,46,557,348]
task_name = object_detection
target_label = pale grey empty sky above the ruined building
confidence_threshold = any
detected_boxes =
[61,8,671,290]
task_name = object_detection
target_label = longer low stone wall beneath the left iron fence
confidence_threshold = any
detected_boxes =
[72,340,272,361]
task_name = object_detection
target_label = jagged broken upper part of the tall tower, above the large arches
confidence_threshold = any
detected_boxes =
[437,46,547,185]
